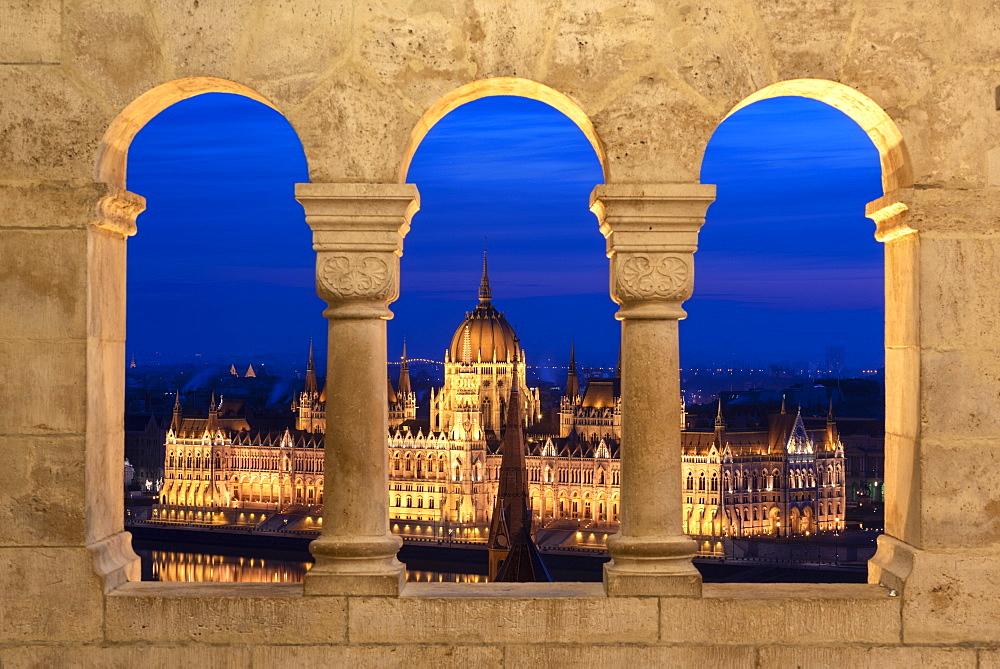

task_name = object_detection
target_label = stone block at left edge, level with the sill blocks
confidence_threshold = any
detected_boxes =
[0,547,104,646]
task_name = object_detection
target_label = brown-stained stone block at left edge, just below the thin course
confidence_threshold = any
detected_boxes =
[0,230,87,340]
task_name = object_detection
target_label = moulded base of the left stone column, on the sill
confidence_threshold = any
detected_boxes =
[304,534,406,597]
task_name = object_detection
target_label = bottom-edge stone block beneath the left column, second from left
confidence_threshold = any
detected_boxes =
[252,644,504,669]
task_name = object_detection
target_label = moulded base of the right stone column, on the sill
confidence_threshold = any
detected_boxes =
[604,535,701,597]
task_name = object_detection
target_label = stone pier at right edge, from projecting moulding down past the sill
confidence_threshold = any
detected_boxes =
[868,188,1000,643]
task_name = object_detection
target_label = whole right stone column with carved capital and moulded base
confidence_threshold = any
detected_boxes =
[591,183,715,596]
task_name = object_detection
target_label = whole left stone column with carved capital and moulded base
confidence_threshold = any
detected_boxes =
[295,183,418,595]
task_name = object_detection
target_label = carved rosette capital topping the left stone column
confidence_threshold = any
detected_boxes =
[295,183,420,320]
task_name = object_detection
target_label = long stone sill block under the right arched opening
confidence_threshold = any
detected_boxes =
[660,583,900,644]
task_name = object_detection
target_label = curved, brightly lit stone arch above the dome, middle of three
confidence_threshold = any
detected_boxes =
[399,77,609,183]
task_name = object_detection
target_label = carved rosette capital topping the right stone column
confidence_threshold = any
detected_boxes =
[590,183,715,320]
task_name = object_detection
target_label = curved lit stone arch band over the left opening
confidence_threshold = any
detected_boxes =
[94,77,287,190]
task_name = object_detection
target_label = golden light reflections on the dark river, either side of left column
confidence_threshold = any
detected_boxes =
[136,545,489,583]
